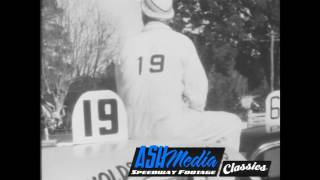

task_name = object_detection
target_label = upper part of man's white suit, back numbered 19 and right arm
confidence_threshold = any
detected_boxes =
[116,22,208,138]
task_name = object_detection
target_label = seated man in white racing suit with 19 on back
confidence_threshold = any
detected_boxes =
[116,0,241,150]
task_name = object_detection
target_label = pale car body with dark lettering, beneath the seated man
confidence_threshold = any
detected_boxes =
[41,140,245,180]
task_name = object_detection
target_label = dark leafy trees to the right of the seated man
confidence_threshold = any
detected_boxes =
[172,0,280,110]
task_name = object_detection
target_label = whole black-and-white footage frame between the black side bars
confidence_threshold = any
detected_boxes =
[40,0,280,180]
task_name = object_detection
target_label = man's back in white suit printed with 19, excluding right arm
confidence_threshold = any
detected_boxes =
[117,23,201,137]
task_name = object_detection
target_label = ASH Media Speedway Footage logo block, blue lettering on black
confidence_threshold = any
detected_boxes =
[129,145,225,176]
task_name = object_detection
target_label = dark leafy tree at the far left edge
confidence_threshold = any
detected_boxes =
[41,0,71,128]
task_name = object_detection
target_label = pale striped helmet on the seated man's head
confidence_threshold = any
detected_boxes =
[141,0,174,20]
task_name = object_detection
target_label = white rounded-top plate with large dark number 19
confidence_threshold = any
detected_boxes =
[72,90,128,144]
